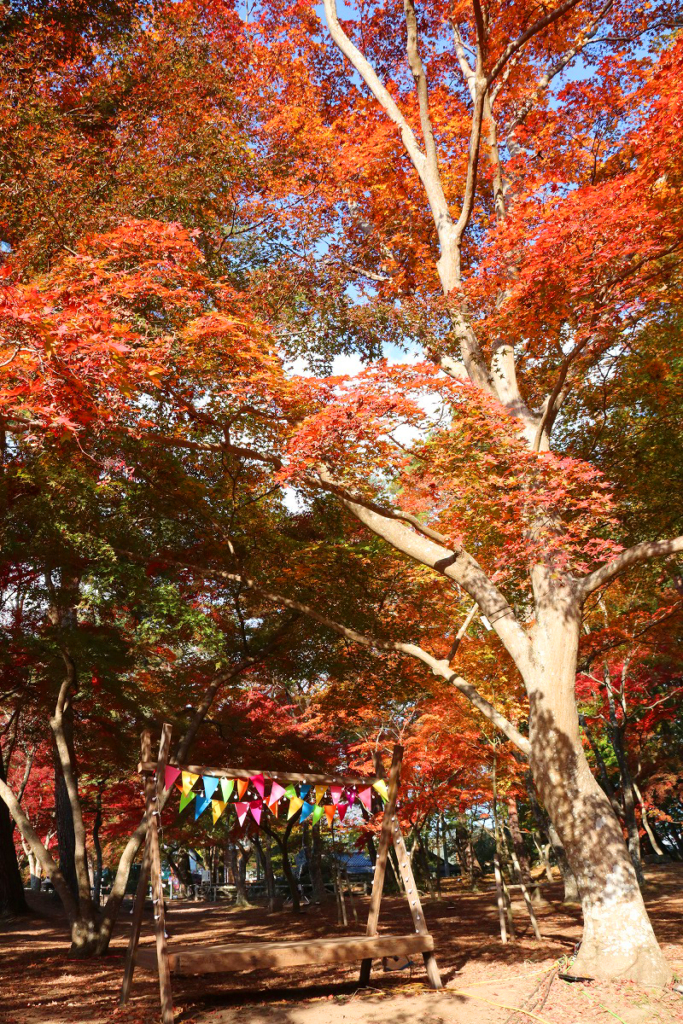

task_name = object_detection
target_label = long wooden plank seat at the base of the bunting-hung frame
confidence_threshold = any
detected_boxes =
[135,933,434,975]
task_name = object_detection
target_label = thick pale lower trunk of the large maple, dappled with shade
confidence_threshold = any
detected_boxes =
[525,587,670,986]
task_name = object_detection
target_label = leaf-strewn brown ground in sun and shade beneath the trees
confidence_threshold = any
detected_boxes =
[0,864,683,1024]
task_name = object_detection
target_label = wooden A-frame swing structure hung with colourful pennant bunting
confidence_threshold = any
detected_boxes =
[121,725,441,1024]
